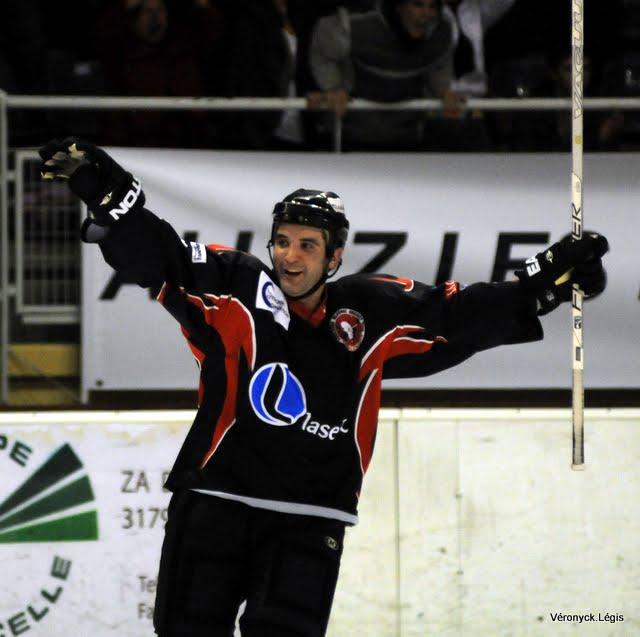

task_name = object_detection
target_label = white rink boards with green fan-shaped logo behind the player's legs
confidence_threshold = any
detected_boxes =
[0,409,640,637]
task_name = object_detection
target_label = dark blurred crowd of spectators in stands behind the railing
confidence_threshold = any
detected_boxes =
[0,0,640,151]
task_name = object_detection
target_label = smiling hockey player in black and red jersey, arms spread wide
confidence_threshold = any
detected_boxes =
[40,138,607,637]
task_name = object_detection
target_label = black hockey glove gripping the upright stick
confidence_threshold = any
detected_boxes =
[515,232,609,315]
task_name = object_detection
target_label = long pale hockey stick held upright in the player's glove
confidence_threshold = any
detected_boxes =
[571,0,584,471]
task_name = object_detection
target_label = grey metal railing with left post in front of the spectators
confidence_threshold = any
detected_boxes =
[0,91,640,404]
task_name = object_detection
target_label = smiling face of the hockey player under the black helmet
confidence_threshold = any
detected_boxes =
[273,223,342,309]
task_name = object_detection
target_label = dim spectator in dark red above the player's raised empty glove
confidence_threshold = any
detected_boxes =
[96,0,223,147]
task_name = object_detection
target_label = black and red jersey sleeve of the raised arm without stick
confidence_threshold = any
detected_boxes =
[89,208,262,365]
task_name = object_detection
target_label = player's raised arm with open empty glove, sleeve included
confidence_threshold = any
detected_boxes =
[40,138,252,353]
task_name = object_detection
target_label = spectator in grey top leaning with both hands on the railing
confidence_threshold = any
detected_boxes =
[310,0,486,150]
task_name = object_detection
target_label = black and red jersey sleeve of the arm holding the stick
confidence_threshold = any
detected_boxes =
[363,277,543,378]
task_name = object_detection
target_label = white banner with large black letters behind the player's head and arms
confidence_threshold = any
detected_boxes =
[82,149,640,393]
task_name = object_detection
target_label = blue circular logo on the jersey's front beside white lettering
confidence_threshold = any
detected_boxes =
[249,363,307,427]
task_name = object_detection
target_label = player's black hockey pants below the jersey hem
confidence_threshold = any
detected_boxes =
[154,491,345,637]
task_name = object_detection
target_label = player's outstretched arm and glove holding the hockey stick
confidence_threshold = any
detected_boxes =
[385,233,608,378]
